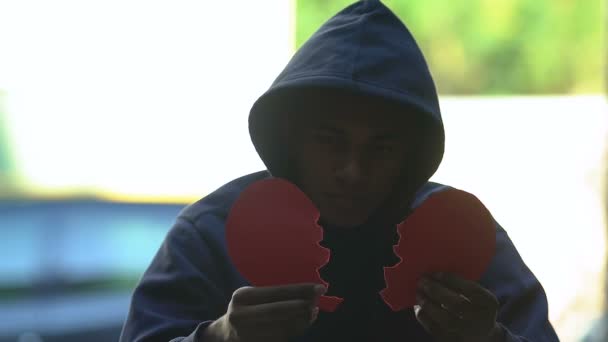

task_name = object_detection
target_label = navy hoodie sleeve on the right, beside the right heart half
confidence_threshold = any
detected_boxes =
[481,224,559,342]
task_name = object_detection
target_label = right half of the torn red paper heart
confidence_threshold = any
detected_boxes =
[380,189,496,311]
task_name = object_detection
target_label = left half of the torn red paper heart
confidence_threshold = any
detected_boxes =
[226,178,342,312]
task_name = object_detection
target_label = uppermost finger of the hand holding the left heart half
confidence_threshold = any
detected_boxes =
[232,283,325,305]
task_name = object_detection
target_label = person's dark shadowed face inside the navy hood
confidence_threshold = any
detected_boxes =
[291,104,412,228]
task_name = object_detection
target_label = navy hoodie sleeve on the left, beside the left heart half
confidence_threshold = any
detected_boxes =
[120,217,229,342]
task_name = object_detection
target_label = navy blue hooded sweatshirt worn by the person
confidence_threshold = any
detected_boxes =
[121,1,558,342]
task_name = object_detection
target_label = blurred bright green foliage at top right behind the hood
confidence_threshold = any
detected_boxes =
[296,0,606,95]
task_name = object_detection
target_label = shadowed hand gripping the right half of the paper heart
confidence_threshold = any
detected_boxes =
[414,273,504,342]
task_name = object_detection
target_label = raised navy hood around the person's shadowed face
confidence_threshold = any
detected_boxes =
[249,0,445,223]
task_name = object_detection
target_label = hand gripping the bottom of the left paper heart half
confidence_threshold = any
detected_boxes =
[205,283,326,342]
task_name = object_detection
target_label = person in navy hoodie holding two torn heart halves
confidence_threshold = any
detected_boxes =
[121,1,558,342]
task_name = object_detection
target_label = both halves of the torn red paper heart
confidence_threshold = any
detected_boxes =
[226,178,496,312]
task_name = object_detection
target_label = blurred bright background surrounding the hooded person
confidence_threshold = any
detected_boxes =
[0,0,608,342]
